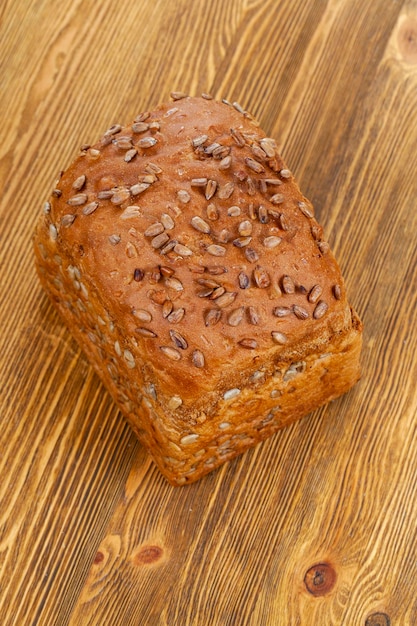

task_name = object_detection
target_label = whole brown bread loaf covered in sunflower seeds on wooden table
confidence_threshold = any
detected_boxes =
[34,94,361,485]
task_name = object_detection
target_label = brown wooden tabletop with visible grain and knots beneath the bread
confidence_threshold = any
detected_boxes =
[0,0,417,626]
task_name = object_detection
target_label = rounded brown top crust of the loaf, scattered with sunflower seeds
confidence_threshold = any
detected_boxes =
[38,97,351,405]
